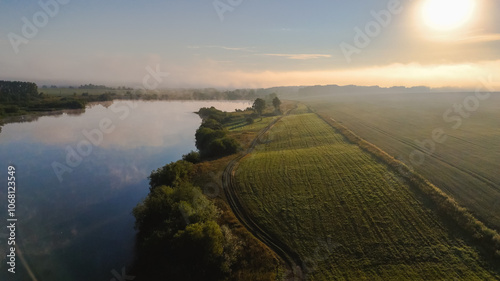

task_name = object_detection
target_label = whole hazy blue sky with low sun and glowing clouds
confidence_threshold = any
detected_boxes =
[0,0,500,89]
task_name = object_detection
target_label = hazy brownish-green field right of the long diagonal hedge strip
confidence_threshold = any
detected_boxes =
[300,93,500,230]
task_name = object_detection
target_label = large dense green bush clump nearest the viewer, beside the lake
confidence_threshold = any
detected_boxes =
[133,160,241,280]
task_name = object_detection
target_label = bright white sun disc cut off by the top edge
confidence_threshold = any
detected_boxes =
[422,0,476,31]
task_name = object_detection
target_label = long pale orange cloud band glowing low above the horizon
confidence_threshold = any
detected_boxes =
[183,60,500,88]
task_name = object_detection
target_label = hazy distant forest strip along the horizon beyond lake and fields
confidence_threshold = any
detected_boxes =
[0,81,451,118]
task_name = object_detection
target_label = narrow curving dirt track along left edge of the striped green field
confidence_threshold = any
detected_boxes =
[222,106,305,281]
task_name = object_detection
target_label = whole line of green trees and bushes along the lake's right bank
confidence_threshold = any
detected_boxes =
[132,104,278,281]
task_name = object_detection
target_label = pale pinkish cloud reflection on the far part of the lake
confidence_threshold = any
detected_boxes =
[0,101,247,149]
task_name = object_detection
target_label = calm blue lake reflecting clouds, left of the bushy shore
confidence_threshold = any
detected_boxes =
[0,101,251,281]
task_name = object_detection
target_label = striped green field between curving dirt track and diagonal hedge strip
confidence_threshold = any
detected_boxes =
[236,110,500,280]
